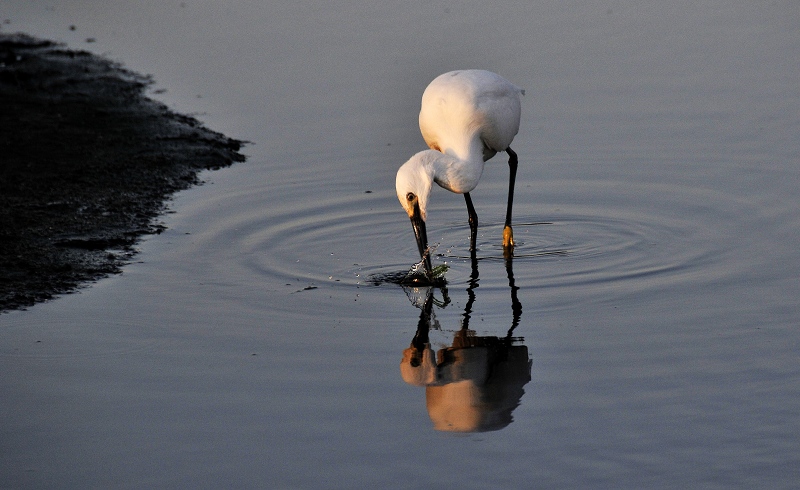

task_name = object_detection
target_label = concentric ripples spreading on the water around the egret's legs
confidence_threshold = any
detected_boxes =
[169,169,748,314]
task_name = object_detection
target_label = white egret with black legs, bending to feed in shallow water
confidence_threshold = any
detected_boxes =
[395,70,525,275]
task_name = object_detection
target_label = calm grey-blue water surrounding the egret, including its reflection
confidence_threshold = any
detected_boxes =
[0,0,800,488]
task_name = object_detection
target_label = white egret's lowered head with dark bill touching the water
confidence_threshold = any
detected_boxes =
[395,152,433,272]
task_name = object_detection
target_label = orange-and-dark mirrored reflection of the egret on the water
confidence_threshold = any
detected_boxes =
[400,257,531,432]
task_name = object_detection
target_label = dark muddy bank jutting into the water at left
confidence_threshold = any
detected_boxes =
[0,34,244,312]
